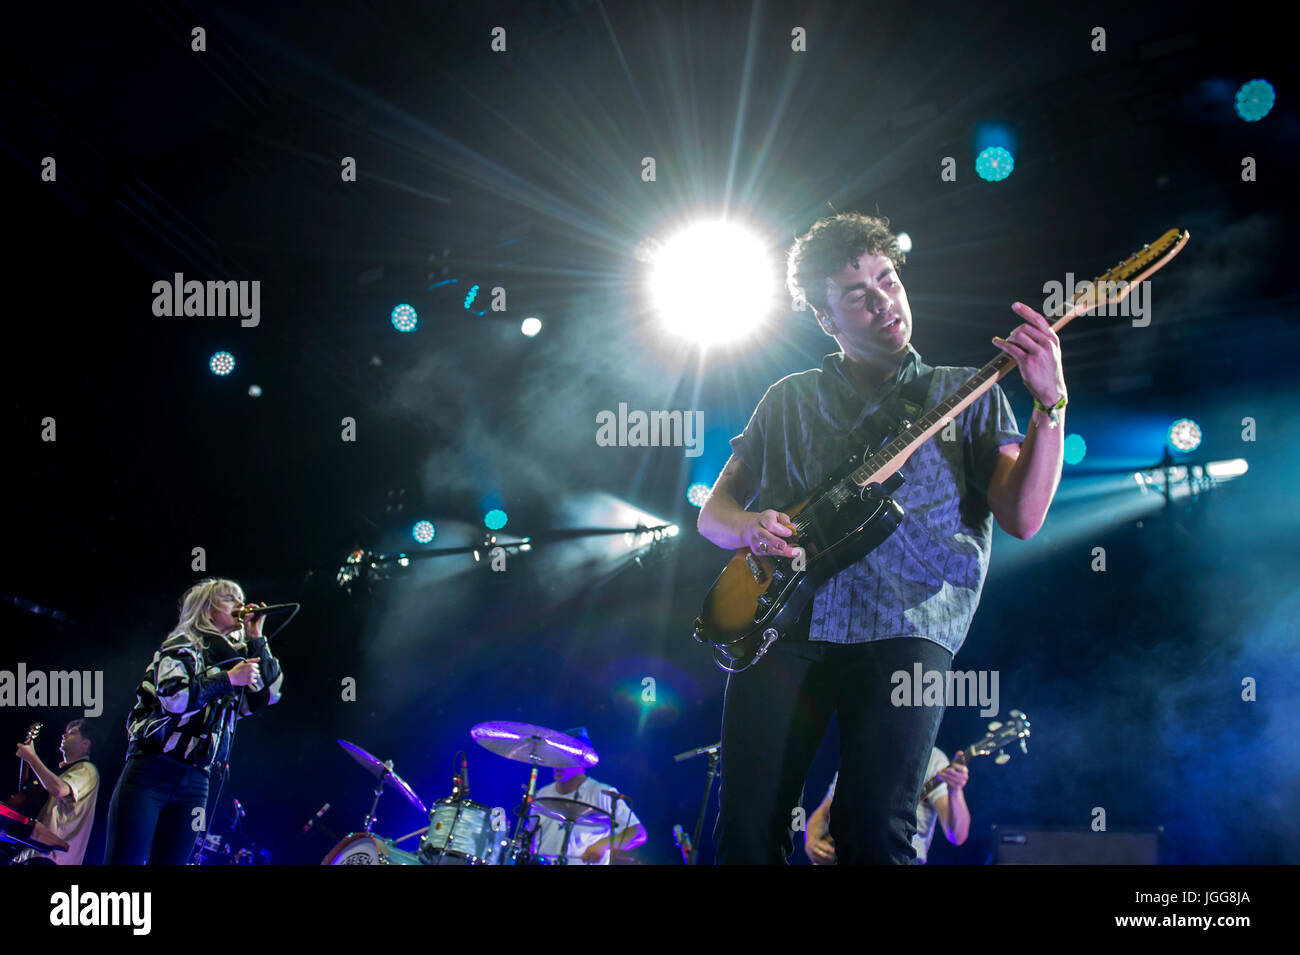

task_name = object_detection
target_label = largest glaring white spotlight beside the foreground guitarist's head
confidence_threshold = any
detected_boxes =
[650,222,775,346]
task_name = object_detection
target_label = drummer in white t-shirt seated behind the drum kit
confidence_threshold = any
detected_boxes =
[533,726,646,865]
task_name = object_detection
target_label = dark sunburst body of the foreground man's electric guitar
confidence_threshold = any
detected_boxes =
[693,455,904,673]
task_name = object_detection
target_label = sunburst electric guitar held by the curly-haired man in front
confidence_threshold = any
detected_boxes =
[692,229,1190,673]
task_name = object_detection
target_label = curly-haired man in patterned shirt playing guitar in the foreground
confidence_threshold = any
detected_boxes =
[698,213,1066,864]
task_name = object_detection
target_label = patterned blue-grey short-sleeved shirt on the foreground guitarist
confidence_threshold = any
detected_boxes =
[731,346,1024,654]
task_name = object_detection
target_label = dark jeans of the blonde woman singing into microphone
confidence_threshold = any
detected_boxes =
[104,756,208,865]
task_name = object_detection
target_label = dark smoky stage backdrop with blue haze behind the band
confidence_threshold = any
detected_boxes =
[0,0,1300,863]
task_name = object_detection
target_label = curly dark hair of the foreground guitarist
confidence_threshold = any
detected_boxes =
[785,212,907,312]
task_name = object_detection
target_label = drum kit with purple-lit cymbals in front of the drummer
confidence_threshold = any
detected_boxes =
[321,721,614,865]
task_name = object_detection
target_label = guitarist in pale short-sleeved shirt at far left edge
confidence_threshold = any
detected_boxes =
[14,720,99,865]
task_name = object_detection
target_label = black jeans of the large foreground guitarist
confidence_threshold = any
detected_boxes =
[714,637,953,865]
